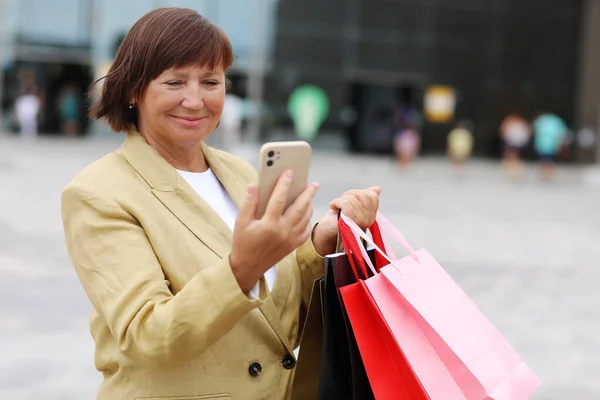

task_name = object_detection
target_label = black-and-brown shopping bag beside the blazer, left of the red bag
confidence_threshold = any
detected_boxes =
[292,217,380,400]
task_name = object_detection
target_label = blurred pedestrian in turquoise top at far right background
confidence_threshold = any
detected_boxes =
[533,113,568,180]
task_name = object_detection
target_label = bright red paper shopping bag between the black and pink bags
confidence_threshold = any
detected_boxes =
[338,220,429,400]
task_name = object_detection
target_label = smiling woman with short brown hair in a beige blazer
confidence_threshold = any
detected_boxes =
[62,8,380,400]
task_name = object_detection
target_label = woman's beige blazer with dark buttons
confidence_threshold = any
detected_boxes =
[62,132,323,400]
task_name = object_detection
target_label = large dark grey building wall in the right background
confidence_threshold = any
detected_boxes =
[267,0,582,153]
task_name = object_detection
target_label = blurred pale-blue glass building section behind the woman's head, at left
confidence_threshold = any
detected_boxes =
[0,0,277,135]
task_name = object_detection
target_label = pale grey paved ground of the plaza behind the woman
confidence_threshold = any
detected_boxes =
[0,137,600,400]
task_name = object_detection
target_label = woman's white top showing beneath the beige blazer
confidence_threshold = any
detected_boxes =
[177,168,276,299]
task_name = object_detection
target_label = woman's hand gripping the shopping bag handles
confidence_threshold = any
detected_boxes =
[312,186,381,255]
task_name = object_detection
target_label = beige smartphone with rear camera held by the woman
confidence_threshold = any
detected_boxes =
[256,141,312,218]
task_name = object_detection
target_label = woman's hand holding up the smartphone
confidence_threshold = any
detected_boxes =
[229,171,319,293]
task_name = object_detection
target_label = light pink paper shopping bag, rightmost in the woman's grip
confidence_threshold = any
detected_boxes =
[342,214,541,400]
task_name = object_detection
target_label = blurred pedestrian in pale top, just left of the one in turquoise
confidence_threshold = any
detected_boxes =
[500,113,531,178]
